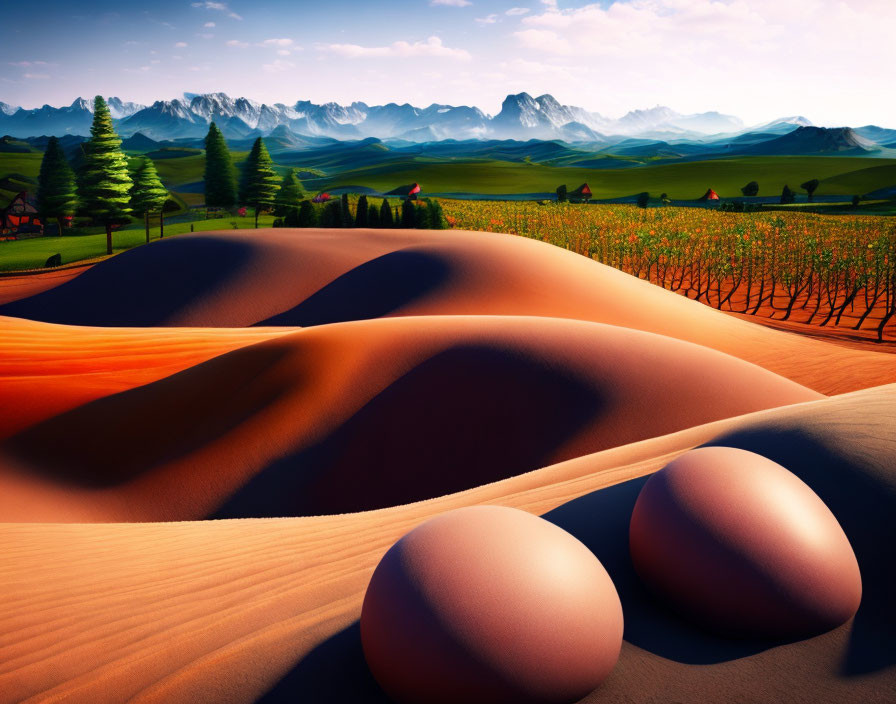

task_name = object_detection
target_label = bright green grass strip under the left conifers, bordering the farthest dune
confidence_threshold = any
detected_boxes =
[0,215,274,271]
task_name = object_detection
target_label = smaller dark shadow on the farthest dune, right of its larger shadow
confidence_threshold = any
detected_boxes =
[257,250,451,327]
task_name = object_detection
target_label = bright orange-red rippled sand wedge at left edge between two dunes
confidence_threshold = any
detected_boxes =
[0,316,292,439]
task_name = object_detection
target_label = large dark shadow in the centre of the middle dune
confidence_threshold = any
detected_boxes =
[213,344,608,518]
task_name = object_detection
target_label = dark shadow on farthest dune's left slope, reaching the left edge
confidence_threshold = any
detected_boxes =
[0,237,253,327]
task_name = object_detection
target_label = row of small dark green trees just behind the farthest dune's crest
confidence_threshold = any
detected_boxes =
[274,193,448,230]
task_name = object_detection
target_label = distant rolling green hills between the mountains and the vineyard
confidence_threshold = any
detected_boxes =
[0,150,896,205]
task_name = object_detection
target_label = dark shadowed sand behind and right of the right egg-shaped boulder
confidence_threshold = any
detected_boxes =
[708,425,896,675]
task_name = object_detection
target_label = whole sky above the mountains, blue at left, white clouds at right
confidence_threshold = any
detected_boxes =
[0,0,896,127]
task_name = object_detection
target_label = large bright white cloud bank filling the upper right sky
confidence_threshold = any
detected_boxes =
[510,0,896,121]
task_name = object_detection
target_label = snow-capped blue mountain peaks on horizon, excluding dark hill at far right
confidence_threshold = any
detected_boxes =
[0,93,891,145]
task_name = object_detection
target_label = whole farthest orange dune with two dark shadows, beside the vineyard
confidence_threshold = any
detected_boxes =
[0,229,896,394]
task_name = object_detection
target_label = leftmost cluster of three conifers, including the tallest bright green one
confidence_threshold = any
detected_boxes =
[37,96,168,254]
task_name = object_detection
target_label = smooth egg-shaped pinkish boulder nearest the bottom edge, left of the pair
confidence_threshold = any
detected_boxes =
[361,506,623,704]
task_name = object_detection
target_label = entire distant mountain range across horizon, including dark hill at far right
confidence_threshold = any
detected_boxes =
[0,93,896,159]
